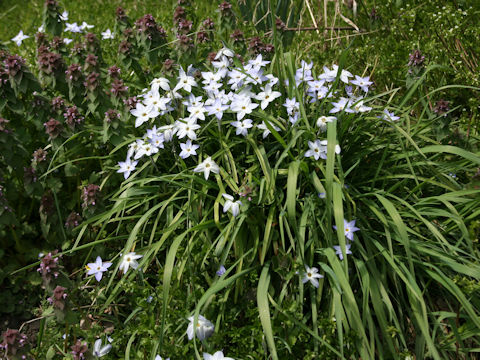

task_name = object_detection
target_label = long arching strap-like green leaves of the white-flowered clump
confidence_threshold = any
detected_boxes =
[57,52,480,359]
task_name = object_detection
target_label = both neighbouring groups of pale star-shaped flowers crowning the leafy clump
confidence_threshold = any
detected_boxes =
[118,48,398,211]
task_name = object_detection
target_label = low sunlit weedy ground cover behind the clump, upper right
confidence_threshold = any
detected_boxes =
[288,0,480,136]
